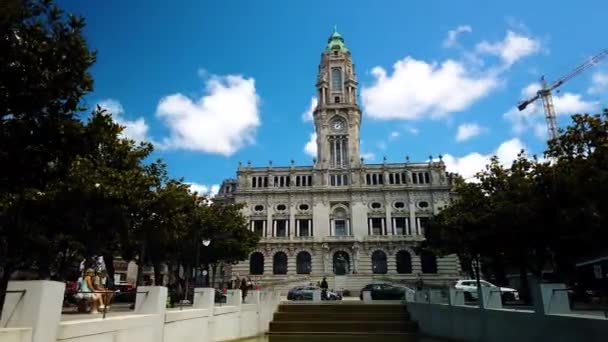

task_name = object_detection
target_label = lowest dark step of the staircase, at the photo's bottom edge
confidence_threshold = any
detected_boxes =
[267,332,418,342]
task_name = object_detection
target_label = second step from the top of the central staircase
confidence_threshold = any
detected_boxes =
[273,311,410,322]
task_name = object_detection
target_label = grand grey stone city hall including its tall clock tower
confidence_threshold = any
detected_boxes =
[216,31,460,291]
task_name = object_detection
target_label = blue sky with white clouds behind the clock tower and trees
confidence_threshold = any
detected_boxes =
[58,0,608,191]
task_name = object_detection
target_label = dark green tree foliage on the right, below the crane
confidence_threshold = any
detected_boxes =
[427,111,608,284]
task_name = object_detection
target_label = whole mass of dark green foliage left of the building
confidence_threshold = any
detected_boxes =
[0,0,258,294]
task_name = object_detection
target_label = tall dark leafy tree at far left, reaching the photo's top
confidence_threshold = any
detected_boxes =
[0,0,95,312]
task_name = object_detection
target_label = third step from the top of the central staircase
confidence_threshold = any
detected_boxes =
[269,321,418,333]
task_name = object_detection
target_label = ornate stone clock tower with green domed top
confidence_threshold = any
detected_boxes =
[313,28,361,172]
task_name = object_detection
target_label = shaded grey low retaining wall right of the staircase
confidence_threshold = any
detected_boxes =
[407,284,608,342]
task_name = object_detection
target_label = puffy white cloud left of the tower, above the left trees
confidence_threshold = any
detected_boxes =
[156,75,260,156]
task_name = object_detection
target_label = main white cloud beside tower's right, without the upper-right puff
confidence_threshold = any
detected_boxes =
[361,57,499,120]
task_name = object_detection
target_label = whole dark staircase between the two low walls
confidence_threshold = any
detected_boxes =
[268,301,418,342]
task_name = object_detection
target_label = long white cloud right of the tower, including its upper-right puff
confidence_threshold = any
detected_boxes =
[361,27,541,120]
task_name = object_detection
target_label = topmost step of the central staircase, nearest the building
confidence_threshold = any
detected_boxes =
[278,302,407,314]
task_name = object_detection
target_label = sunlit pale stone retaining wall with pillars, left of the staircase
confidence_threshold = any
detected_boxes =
[0,281,280,342]
